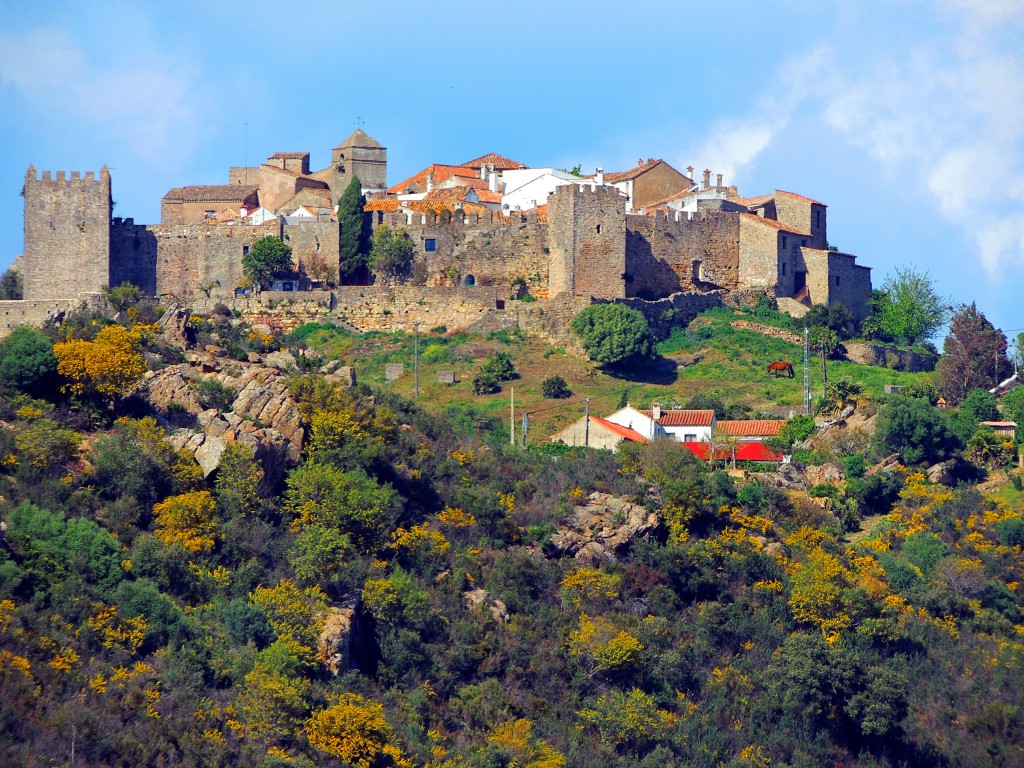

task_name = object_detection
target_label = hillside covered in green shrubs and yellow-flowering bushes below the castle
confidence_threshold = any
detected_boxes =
[0,307,1024,768]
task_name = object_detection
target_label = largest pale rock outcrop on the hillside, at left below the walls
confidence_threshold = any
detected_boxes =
[137,348,305,493]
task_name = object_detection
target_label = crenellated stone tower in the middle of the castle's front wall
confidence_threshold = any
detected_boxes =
[548,184,626,299]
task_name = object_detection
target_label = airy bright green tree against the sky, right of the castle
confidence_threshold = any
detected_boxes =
[870,266,949,345]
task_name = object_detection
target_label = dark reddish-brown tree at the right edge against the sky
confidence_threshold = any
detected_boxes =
[936,304,1012,402]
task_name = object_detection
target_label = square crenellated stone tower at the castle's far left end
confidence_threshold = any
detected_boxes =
[24,165,112,300]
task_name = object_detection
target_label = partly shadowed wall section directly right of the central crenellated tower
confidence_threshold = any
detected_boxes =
[626,211,739,298]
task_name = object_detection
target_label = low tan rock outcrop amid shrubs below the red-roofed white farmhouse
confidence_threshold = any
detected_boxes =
[551,493,662,563]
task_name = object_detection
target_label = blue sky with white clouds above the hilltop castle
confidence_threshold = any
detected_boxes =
[0,0,1024,339]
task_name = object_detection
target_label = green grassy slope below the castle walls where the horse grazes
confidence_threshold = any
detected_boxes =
[296,312,931,442]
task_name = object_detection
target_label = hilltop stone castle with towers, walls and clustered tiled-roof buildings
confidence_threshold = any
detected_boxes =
[0,130,871,332]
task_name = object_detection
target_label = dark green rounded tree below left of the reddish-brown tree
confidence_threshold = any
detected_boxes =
[874,395,959,464]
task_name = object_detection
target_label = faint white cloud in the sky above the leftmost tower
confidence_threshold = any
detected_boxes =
[0,29,203,163]
